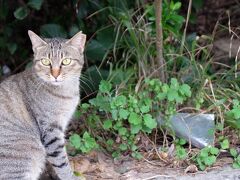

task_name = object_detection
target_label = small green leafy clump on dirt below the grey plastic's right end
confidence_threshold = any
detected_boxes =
[195,147,219,171]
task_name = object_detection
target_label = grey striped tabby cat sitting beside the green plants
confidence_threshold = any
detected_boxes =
[0,31,86,180]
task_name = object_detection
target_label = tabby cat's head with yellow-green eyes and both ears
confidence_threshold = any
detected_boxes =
[28,30,86,85]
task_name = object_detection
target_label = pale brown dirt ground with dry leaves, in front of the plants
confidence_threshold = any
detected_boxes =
[41,152,240,180]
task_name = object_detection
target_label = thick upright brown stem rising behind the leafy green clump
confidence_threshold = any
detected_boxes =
[155,0,166,82]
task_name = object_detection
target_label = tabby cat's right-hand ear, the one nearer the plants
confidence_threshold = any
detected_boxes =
[66,31,87,53]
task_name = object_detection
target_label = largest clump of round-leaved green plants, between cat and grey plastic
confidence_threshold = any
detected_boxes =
[73,78,191,159]
